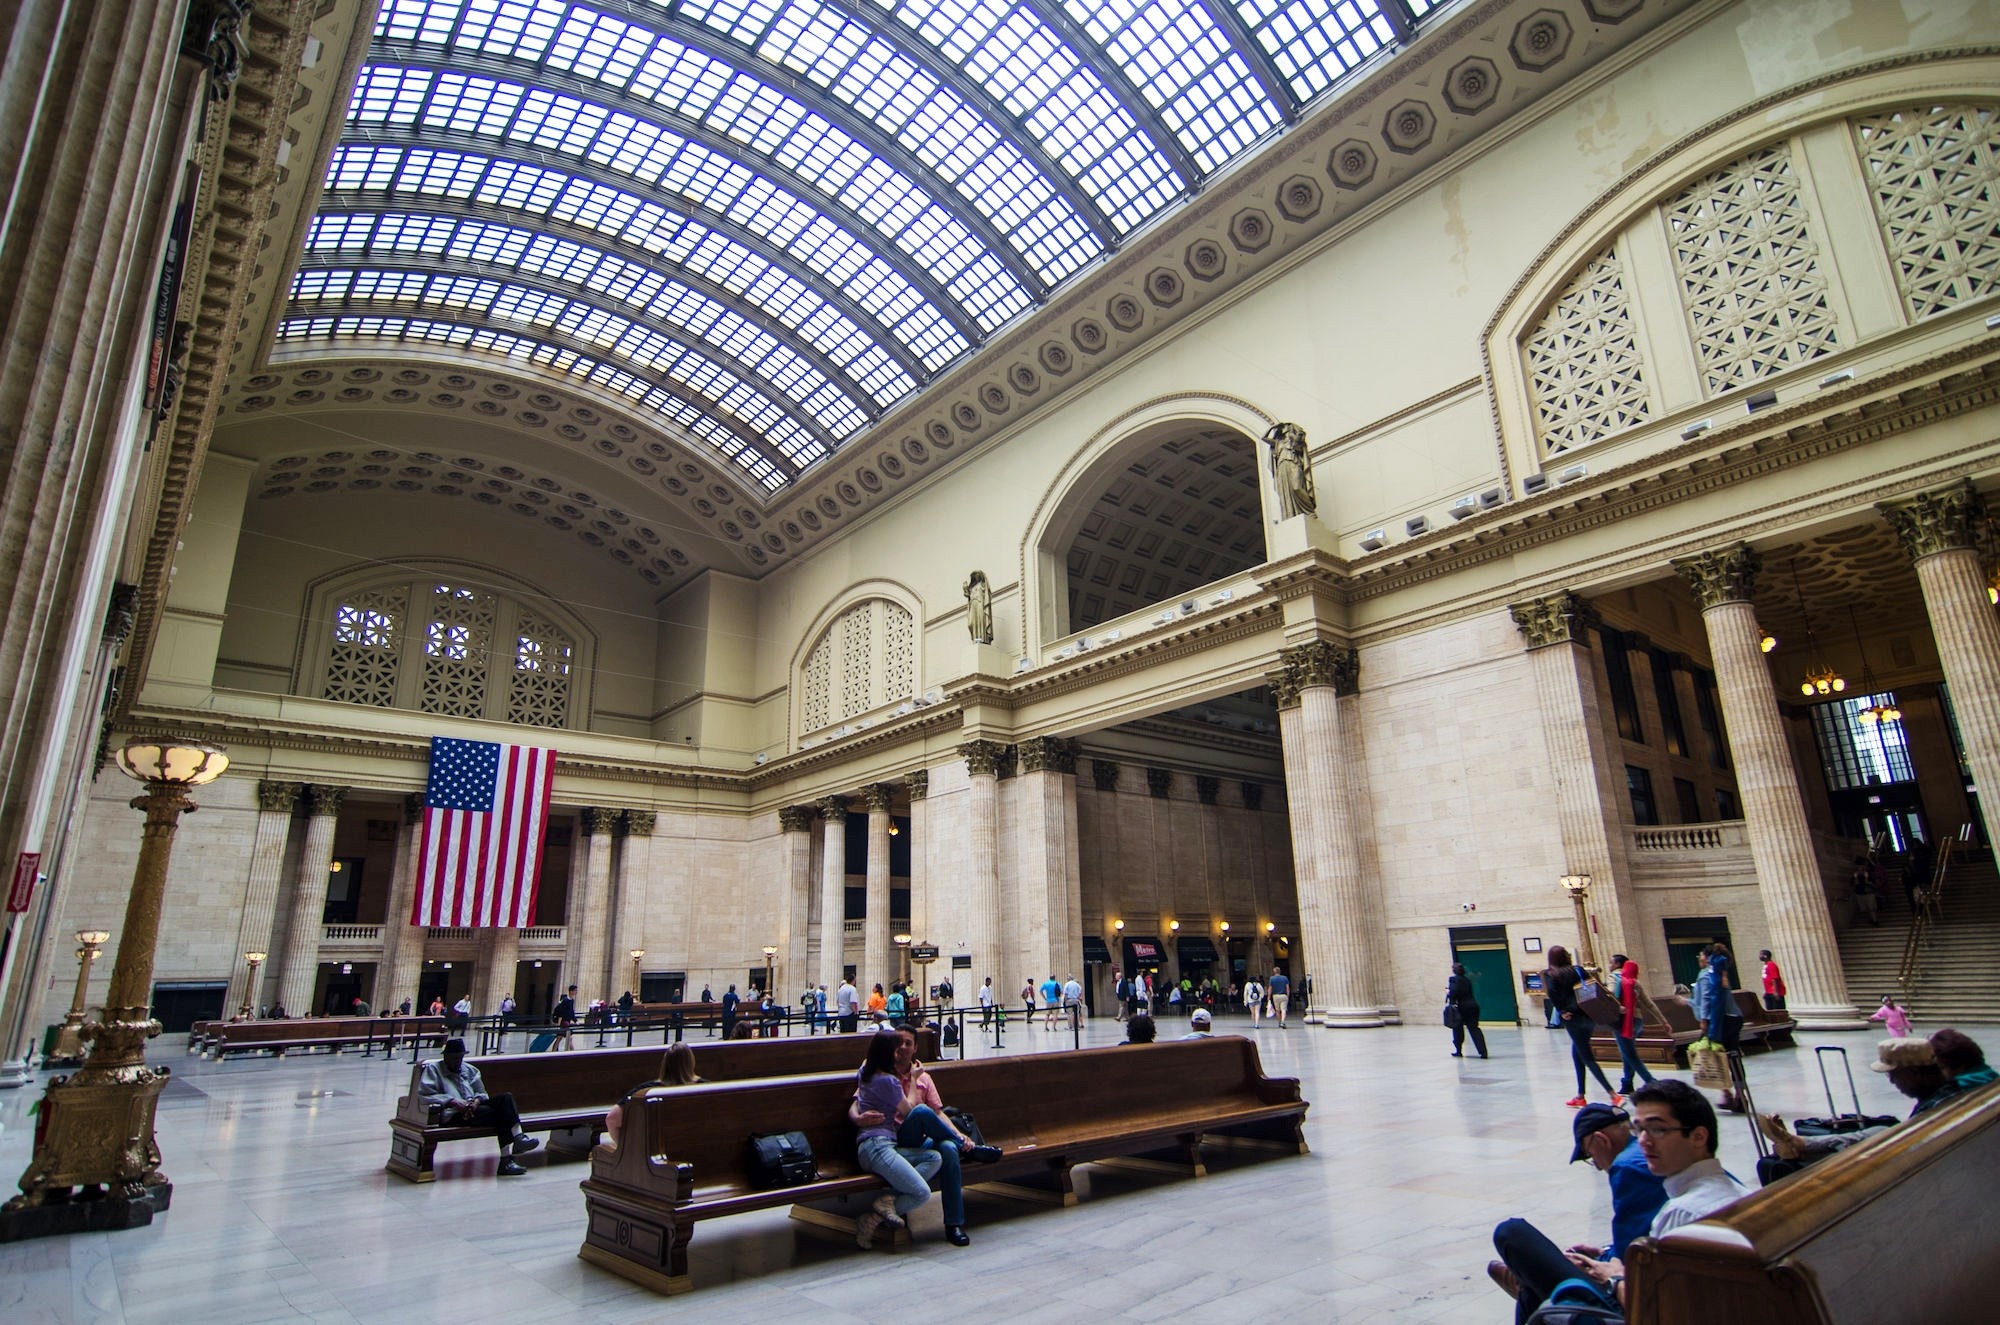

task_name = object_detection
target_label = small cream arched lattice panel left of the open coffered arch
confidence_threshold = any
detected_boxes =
[792,580,924,741]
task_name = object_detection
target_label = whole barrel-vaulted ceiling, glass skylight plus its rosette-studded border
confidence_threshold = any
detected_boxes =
[228,0,1686,578]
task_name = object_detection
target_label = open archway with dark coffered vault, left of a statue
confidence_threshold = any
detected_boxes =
[1022,392,1276,652]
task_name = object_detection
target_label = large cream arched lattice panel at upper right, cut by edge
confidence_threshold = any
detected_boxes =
[1484,56,2000,488]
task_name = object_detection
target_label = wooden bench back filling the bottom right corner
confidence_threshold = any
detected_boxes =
[1626,1085,2000,1325]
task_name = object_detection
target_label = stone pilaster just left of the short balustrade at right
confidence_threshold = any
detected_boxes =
[1508,592,1636,961]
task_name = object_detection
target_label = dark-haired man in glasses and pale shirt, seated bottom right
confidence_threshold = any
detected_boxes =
[1494,1079,1748,1321]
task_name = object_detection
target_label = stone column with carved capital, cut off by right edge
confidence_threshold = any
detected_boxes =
[1882,480,2000,845]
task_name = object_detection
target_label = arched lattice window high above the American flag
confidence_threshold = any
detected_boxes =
[298,570,588,727]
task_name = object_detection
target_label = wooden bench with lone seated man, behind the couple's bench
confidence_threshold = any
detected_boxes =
[384,1031,938,1183]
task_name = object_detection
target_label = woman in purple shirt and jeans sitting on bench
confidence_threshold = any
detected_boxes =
[848,1031,972,1247]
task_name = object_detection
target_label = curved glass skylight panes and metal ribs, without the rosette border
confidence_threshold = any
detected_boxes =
[278,0,1448,492]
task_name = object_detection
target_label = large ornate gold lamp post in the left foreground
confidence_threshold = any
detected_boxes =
[0,741,230,1241]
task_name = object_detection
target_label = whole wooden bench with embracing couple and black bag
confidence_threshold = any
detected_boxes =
[578,1035,1306,1293]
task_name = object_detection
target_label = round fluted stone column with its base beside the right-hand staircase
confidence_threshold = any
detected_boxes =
[1674,542,1866,1031]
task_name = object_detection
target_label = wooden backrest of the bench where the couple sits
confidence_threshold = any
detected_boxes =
[592,1037,1300,1197]
